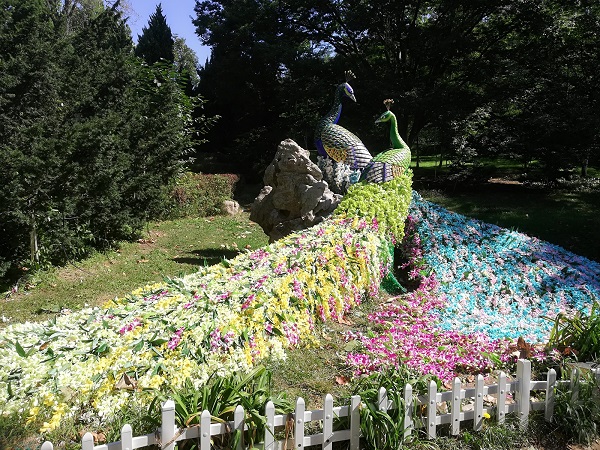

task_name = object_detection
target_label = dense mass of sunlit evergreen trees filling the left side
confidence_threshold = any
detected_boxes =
[0,0,211,276]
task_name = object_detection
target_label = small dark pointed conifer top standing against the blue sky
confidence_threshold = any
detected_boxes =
[135,3,175,64]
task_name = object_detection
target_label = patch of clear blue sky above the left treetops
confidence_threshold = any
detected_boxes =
[127,0,210,65]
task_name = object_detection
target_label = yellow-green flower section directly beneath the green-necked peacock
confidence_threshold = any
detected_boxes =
[335,170,412,242]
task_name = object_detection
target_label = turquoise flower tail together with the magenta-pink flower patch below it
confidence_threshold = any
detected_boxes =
[347,192,600,382]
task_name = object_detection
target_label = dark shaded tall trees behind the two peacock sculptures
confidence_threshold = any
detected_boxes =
[194,0,600,183]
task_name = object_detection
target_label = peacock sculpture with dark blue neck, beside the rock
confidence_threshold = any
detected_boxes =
[315,70,373,171]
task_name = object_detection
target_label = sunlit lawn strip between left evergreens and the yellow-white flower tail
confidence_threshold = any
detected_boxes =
[0,212,268,327]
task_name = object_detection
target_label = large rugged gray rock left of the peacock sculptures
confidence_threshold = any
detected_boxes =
[250,139,342,242]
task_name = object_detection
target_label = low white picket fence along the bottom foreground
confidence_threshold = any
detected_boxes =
[41,360,600,450]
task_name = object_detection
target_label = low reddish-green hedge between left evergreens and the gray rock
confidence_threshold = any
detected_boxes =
[164,172,239,218]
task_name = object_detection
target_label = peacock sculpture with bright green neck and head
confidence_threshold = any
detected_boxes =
[360,99,411,183]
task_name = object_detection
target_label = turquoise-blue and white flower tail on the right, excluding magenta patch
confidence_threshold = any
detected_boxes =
[410,194,600,342]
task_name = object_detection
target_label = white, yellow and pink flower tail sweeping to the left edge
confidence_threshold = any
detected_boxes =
[0,171,410,432]
